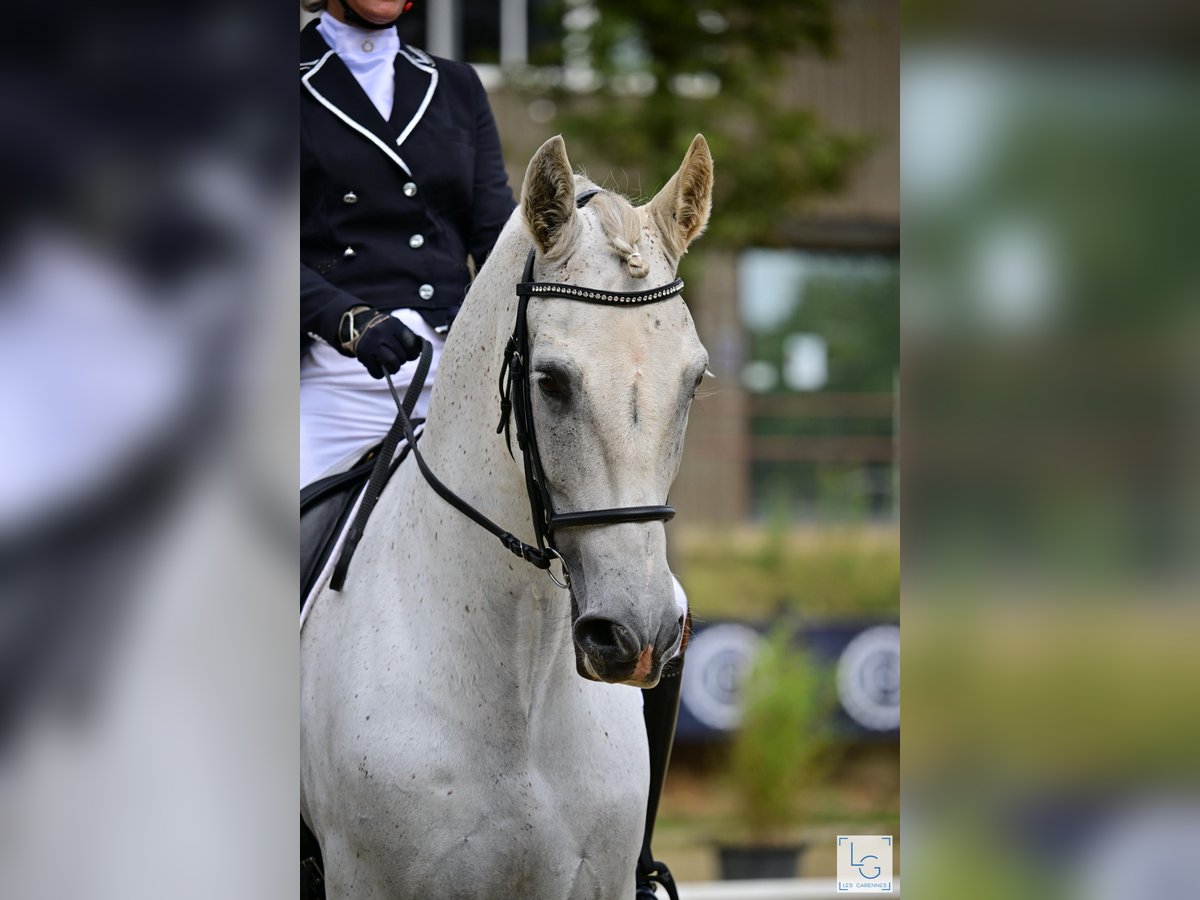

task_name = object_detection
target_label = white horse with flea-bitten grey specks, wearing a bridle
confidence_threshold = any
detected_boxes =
[300,136,713,900]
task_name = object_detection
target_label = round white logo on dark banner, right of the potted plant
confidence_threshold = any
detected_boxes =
[838,625,900,731]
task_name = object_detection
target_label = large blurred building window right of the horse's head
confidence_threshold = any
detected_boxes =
[738,250,900,520]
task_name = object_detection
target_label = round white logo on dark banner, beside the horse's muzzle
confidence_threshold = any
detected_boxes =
[679,624,762,731]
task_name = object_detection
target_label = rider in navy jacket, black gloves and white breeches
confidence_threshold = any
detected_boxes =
[300,0,515,487]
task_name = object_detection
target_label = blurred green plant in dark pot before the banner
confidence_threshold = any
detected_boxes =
[718,624,834,878]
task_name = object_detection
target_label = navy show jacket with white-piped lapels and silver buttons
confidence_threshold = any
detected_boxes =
[300,22,515,350]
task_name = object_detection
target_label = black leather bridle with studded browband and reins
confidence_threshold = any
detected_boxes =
[330,188,683,590]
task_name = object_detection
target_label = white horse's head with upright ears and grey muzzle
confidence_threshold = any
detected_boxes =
[521,134,713,688]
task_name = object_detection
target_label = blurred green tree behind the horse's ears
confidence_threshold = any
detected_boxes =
[514,0,869,246]
